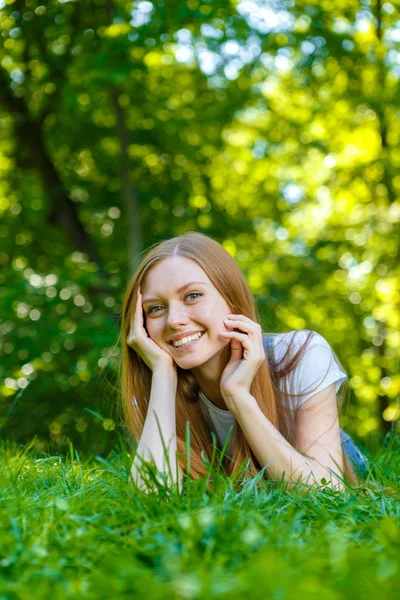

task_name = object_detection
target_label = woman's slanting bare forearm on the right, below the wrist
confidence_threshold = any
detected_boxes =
[235,394,342,488]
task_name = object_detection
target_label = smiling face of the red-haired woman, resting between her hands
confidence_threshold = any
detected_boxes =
[141,256,231,369]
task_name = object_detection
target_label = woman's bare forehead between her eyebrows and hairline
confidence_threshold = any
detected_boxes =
[142,256,211,294]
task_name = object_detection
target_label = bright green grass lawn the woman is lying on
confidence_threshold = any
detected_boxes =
[0,434,400,600]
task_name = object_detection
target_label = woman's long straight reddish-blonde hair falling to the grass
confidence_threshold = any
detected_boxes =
[120,232,357,490]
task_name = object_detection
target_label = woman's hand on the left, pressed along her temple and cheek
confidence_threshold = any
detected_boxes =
[127,288,176,373]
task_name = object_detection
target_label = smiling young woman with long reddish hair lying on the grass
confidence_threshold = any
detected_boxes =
[121,232,365,490]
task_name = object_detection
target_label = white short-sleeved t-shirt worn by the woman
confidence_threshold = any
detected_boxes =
[199,331,347,457]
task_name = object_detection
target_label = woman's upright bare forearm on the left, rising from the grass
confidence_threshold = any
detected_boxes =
[132,370,181,490]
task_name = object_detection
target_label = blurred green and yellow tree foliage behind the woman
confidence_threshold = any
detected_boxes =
[0,0,400,453]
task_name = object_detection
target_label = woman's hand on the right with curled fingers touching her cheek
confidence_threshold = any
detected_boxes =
[220,315,266,408]
